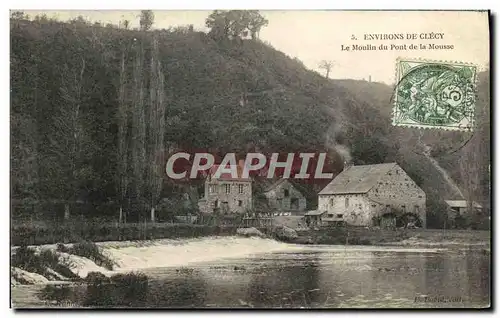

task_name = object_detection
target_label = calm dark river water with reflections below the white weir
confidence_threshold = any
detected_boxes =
[12,246,490,308]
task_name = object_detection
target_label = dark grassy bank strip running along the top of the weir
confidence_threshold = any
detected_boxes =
[11,222,236,246]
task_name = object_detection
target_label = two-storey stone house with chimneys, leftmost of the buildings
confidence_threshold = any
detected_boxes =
[198,161,252,215]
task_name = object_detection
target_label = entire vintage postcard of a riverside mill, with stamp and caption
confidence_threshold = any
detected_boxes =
[10,10,492,309]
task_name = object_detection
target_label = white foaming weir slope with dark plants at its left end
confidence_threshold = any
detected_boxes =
[11,236,300,285]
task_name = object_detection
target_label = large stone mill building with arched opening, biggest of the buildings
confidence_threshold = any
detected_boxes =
[318,163,426,228]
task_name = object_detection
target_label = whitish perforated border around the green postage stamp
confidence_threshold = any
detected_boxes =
[391,57,479,132]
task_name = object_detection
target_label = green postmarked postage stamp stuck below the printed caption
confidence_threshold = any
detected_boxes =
[392,59,476,131]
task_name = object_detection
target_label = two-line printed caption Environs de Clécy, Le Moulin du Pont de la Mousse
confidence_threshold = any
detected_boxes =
[340,32,454,52]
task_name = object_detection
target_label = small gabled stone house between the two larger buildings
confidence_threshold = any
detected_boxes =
[263,179,307,214]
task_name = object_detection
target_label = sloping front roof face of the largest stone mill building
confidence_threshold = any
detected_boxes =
[318,162,397,195]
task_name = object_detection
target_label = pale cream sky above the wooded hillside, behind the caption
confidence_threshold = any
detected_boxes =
[25,10,489,84]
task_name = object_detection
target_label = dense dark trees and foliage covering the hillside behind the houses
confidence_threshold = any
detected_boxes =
[11,11,489,229]
